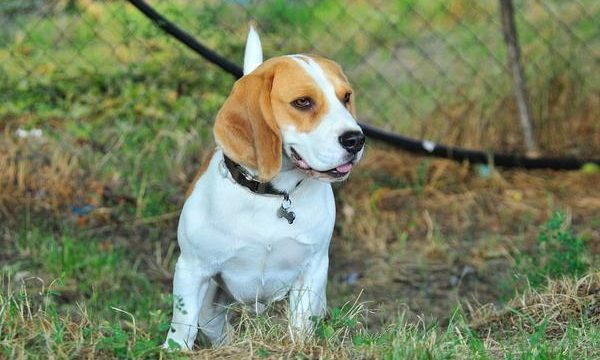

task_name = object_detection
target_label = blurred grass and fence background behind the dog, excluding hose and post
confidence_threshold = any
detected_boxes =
[0,0,600,353]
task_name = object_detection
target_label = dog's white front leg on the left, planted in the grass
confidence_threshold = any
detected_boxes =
[163,256,210,350]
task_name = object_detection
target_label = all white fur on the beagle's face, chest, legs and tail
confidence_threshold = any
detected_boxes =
[165,29,362,349]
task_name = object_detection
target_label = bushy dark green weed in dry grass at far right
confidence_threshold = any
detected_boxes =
[516,211,590,287]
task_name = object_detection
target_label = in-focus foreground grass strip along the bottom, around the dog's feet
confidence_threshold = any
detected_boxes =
[0,268,600,359]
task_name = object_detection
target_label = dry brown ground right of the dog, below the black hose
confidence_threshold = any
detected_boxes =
[331,146,600,324]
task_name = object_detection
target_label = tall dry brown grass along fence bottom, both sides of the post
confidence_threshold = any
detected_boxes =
[411,83,600,158]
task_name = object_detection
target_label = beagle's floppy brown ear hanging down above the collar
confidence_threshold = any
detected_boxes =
[213,70,282,181]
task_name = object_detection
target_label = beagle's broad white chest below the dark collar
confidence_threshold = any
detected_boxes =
[178,152,335,303]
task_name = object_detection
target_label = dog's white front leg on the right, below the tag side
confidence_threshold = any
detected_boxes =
[289,249,329,339]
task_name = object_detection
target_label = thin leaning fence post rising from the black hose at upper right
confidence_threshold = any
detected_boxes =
[499,0,538,155]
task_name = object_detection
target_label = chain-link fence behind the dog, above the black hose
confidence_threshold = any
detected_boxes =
[0,0,600,155]
